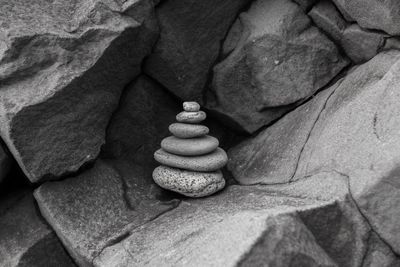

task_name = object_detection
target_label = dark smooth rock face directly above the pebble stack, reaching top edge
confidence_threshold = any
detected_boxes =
[145,0,250,103]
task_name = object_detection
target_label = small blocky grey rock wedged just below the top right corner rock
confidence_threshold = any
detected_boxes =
[341,24,387,64]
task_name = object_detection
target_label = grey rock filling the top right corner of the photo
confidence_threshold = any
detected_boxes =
[333,0,400,35]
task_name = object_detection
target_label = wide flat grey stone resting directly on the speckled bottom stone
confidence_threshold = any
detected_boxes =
[154,148,228,172]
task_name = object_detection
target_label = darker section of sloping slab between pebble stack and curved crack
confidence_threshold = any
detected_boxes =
[228,87,334,184]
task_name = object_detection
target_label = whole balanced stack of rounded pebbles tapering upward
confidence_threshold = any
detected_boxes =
[153,102,228,197]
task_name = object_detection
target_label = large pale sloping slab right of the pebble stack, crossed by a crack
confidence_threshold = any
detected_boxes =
[229,51,400,254]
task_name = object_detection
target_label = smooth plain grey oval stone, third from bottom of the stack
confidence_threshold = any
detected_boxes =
[161,135,219,156]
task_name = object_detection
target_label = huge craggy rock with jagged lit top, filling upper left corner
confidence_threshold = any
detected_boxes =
[0,0,157,182]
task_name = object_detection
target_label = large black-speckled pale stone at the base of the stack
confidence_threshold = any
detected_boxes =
[153,166,225,197]
